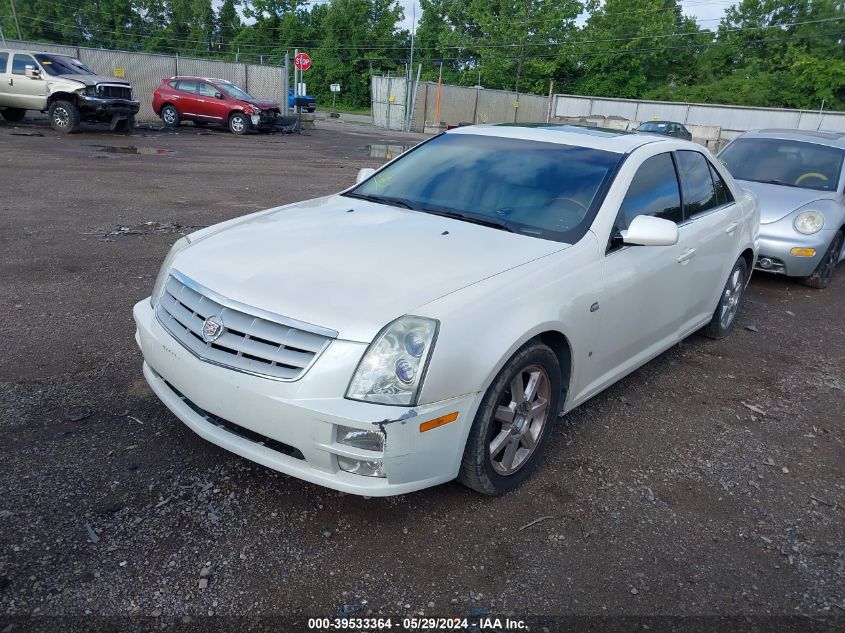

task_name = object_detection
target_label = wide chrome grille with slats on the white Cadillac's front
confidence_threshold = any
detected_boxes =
[156,271,336,380]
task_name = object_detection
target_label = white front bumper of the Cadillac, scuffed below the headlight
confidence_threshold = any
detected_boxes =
[133,299,482,496]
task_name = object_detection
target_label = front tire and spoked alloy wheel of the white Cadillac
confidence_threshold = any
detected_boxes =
[458,341,561,496]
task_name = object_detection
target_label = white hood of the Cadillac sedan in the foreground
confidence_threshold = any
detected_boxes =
[173,195,567,342]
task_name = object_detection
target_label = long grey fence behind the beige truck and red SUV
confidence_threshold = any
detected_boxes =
[0,39,287,121]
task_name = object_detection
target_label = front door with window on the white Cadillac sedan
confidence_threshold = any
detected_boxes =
[588,152,691,393]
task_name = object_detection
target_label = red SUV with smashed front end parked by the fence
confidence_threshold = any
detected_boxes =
[153,77,282,134]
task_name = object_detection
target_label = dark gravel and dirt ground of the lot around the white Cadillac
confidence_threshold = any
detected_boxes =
[0,115,845,633]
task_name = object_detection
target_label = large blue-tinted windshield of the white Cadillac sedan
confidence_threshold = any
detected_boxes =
[345,134,622,243]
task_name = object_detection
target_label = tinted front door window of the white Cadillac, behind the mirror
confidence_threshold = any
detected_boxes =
[613,153,683,232]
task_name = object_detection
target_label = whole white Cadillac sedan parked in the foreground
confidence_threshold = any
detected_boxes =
[134,125,759,496]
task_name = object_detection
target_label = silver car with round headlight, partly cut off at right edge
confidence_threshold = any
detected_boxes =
[719,130,845,288]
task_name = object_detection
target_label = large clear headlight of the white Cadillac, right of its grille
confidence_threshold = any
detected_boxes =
[346,316,439,406]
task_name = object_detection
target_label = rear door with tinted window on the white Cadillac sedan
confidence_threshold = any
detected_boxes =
[675,150,742,326]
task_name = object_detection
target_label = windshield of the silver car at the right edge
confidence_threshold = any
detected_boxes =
[719,138,845,191]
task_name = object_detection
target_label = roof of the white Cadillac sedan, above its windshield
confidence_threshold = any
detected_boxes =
[446,123,672,154]
